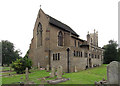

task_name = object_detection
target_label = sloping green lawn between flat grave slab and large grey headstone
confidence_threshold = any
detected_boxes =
[61,65,107,84]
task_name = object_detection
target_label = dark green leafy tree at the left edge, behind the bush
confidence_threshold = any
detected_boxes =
[1,40,21,65]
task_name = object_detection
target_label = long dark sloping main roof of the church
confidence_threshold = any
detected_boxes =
[48,15,79,37]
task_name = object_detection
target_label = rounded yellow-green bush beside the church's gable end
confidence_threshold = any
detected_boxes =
[12,58,32,74]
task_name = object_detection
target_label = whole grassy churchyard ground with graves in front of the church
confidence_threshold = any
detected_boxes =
[0,64,107,84]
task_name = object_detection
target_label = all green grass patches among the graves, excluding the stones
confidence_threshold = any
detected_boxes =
[0,64,107,84]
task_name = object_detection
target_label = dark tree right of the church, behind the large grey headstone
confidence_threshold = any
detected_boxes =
[103,40,119,64]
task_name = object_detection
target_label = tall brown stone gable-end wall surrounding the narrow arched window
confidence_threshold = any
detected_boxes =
[29,9,49,67]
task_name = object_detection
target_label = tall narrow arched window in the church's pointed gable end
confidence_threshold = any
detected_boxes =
[37,23,42,47]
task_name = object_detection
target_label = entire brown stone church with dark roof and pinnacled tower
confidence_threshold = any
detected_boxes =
[29,9,103,72]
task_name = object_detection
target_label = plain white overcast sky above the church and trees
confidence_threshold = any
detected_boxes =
[0,0,119,56]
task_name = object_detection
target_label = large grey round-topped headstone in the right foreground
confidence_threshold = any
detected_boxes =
[107,61,120,84]
